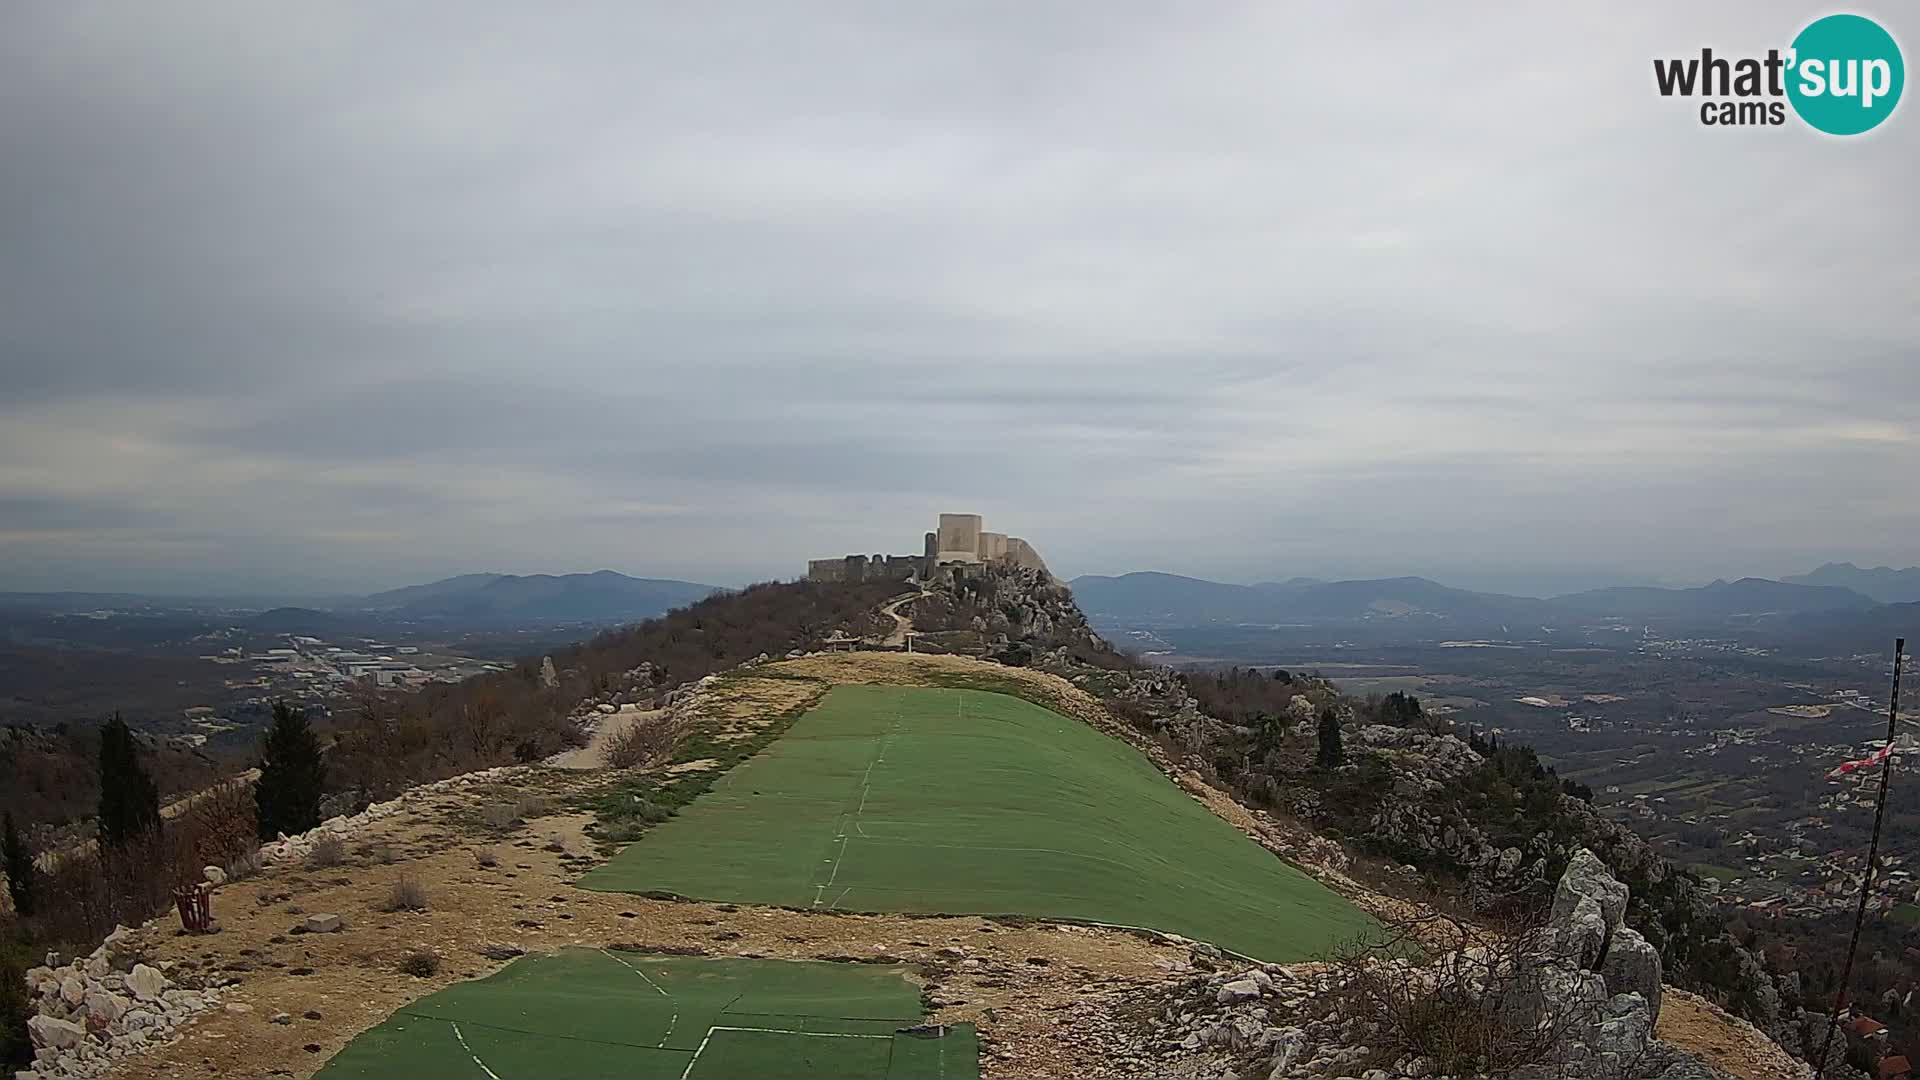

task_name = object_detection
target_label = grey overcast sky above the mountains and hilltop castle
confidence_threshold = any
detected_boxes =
[0,0,1920,590]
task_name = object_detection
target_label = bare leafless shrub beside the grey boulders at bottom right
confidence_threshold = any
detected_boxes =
[1329,909,1596,1078]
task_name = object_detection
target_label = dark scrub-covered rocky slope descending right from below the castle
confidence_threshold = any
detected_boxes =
[914,557,1822,1051]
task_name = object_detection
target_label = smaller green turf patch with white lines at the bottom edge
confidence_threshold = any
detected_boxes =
[319,949,979,1080]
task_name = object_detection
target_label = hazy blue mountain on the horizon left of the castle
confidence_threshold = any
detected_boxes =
[351,571,718,623]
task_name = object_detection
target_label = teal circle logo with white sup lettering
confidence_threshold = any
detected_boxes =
[1788,15,1907,135]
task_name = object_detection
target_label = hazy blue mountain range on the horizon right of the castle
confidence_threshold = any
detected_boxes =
[1069,573,1876,630]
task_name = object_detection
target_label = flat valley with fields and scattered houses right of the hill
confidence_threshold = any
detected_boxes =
[1112,628,1920,919]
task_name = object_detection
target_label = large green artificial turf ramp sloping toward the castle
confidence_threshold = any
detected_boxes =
[580,686,1373,963]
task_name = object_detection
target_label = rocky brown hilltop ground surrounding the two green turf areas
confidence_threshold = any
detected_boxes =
[0,569,1845,1080]
